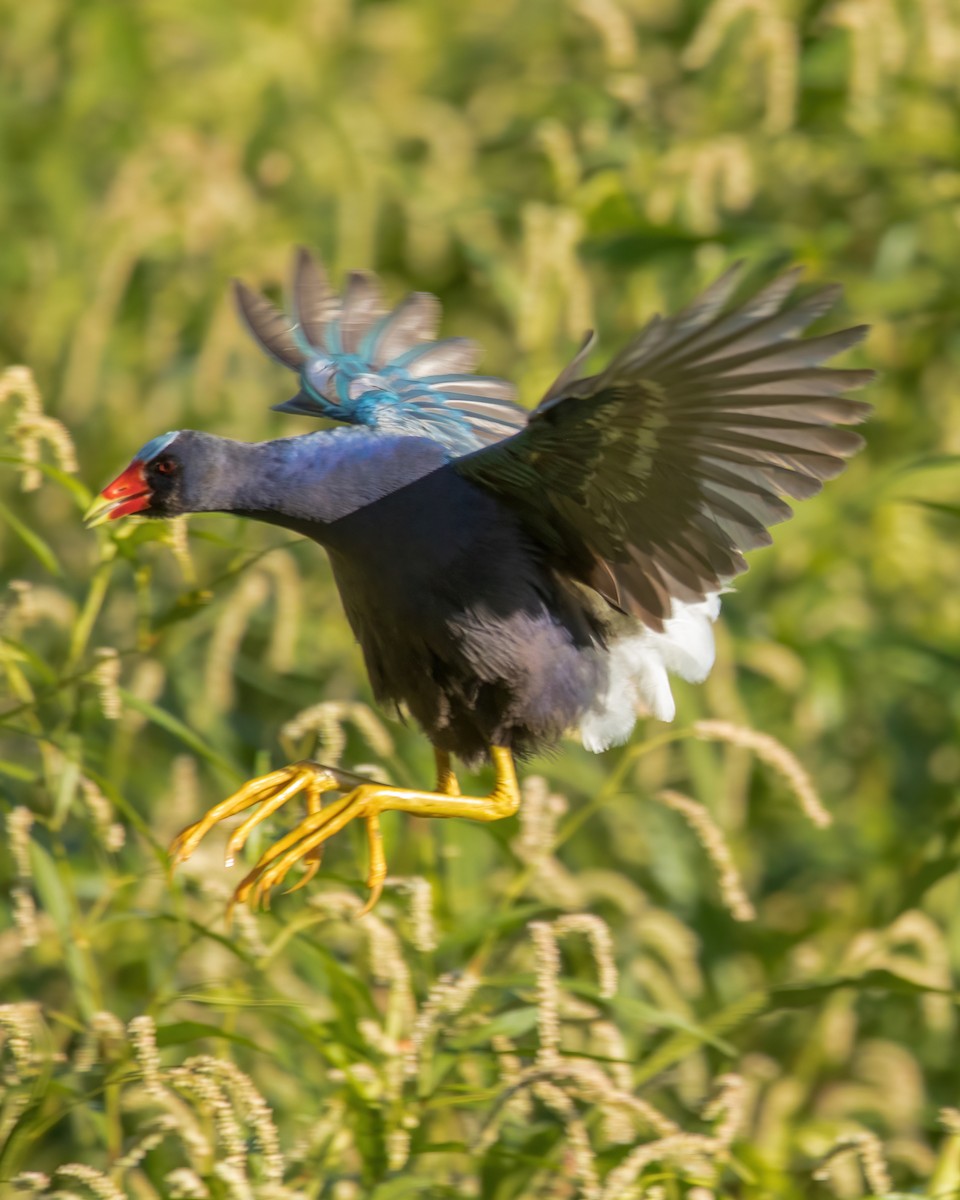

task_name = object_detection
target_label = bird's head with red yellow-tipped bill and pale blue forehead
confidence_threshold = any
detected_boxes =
[84,430,196,528]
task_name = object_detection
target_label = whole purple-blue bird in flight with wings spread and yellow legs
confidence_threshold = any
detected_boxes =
[86,250,874,912]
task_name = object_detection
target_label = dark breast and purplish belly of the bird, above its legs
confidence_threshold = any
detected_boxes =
[321,460,598,758]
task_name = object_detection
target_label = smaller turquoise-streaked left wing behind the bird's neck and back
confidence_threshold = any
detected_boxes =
[234,248,528,454]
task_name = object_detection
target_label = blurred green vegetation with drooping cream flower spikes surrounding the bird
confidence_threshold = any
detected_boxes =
[0,0,960,1200]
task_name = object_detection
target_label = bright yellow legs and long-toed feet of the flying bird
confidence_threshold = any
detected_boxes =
[170,746,520,916]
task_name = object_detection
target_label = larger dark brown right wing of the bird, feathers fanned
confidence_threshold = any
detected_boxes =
[455,266,872,629]
